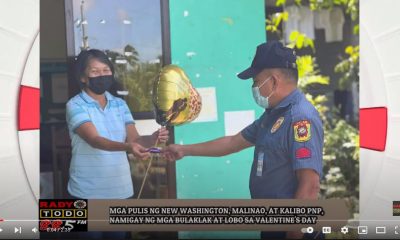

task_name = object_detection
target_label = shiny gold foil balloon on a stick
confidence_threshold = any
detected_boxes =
[153,65,201,126]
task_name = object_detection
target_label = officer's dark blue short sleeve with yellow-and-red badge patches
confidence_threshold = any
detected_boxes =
[289,117,324,178]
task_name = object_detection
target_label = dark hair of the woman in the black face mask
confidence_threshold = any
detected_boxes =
[75,49,114,89]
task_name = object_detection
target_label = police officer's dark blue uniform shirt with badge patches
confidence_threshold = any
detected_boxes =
[241,89,324,199]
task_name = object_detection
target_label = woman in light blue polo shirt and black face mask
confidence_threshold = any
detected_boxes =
[67,49,168,199]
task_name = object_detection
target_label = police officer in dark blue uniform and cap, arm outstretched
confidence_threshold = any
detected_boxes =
[165,41,323,239]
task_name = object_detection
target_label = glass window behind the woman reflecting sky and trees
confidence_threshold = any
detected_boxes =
[73,0,162,112]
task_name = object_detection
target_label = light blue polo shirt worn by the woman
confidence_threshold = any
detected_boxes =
[66,91,134,199]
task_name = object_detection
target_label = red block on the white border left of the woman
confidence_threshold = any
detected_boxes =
[18,85,40,131]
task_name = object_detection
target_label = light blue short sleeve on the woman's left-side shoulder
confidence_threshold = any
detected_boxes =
[66,102,92,132]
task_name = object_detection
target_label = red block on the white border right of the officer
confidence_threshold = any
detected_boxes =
[360,107,388,151]
